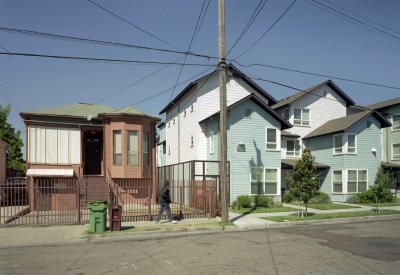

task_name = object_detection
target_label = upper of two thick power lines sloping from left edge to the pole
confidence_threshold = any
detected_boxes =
[0,27,217,59]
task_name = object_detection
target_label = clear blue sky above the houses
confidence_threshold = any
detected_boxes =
[0,0,400,157]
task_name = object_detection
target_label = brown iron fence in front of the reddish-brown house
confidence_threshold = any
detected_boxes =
[0,179,217,226]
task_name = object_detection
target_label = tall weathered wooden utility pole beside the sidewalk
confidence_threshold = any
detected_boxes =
[218,0,229,222]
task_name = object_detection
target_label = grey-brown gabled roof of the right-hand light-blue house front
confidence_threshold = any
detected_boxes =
[303,110,392,139]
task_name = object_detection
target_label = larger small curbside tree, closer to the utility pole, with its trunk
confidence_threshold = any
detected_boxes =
[287,149,319,217]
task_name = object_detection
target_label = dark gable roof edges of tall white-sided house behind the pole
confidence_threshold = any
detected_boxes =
[158,64,278,115]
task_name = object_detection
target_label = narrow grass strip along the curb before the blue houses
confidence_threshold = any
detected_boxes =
[262,210,400,222]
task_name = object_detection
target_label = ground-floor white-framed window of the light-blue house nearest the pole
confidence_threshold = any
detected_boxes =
[250,168,278,195]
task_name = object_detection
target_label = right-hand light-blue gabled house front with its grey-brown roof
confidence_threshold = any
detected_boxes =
[303,110,391,202]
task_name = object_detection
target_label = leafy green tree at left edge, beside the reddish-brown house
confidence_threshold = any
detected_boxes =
[0,104,26,173]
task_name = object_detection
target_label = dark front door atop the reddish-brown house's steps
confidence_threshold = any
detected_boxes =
[85,138,101,175]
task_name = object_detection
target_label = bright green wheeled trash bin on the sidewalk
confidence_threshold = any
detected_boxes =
[88,200,107,233]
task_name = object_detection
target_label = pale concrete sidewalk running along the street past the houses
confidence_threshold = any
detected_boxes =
[0,204,400,246]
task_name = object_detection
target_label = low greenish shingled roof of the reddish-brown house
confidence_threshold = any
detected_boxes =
[20,103,114,118]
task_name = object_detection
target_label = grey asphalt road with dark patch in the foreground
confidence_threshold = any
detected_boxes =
[0,220,400,275]
